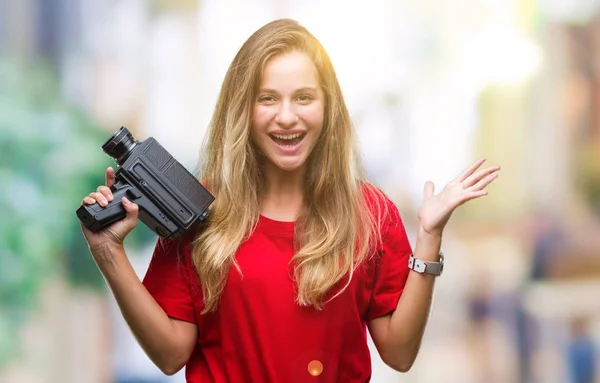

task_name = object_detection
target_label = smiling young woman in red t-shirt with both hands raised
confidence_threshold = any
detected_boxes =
[83,19,499,383]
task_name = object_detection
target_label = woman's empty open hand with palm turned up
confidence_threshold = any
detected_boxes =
[419,158,500,235]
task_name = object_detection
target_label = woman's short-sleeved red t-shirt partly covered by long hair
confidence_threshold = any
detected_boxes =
[144,190,411,383]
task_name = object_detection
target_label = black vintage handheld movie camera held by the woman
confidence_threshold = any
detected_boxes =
[77,127,214,239]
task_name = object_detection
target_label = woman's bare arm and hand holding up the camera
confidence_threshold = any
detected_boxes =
[81,168,198,375]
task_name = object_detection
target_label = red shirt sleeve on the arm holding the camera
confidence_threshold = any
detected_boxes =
[142,237,199,323]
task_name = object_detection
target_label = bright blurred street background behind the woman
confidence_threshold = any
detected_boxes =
[0,0,600,383]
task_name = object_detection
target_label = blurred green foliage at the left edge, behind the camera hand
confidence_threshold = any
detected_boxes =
[0,58,154,368]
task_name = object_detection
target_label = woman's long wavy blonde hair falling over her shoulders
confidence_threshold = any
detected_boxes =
[192,19,385,313]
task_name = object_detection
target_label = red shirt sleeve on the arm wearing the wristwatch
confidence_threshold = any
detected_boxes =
[366,195,412,320]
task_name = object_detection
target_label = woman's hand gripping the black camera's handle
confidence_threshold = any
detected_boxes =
[81,168,139,249]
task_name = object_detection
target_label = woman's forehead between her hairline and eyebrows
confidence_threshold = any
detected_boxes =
[260,51,319,89]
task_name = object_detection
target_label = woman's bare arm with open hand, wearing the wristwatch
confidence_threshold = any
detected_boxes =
[368,159,500,372]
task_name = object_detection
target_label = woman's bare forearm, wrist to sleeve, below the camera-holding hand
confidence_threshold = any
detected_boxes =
[90,244,198,375]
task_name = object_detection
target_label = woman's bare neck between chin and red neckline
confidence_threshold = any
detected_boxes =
[260,164,305,221]
